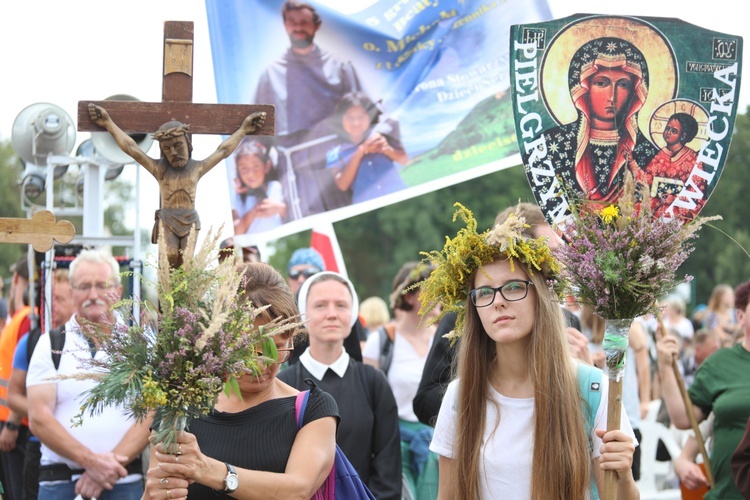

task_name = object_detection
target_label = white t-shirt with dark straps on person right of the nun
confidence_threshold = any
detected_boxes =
[362,331,432,422]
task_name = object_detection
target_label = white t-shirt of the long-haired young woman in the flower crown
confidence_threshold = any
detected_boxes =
[430,377,637,500]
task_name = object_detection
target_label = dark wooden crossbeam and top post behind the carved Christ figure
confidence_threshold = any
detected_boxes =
[78,21,275,135]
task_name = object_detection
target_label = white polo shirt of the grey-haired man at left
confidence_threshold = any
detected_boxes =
[26,316,141,483]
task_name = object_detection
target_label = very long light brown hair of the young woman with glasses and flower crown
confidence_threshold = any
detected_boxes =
[450,261,591,500]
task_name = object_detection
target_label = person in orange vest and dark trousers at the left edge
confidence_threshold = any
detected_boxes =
[0,254,32,499]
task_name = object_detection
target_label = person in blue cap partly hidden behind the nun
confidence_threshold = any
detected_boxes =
[286,248,367,365]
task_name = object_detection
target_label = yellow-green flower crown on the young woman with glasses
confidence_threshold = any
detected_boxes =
[414,203,565,340]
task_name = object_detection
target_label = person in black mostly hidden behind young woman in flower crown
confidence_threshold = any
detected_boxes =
[413,202,592,426]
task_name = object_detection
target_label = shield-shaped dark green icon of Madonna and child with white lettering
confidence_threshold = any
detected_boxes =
[511,14,742,227]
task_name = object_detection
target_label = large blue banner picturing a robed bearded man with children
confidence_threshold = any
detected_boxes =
[206,0,551,244]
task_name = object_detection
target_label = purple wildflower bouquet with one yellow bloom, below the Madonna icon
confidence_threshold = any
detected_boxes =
[555,175,721,320]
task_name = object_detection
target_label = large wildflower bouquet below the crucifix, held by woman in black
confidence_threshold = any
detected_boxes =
[72,227,298,446]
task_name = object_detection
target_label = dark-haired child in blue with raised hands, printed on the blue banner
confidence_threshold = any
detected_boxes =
[326,92,409,203]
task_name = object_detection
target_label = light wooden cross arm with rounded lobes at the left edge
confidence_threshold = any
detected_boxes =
[0,210,76,252]
